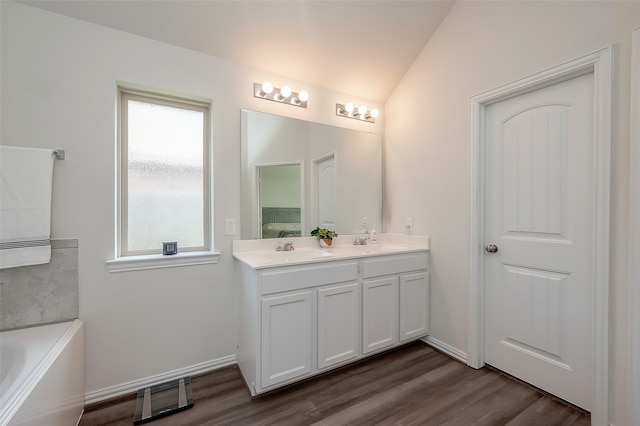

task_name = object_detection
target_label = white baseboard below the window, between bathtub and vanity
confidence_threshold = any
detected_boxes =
[84,355,236,405]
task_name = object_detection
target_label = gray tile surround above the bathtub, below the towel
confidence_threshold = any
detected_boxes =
[0,239,79,331]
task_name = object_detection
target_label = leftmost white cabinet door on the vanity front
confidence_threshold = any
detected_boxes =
[261,291,311,388]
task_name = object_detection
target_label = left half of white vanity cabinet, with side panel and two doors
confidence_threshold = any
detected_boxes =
[238,261,361,395]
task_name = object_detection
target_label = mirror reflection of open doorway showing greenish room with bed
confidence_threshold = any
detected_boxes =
[257,163,304,238]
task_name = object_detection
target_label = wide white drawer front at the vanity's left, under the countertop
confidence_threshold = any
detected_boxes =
[260,262,358,294]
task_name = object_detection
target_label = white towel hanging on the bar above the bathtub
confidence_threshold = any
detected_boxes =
[0,145,54,269]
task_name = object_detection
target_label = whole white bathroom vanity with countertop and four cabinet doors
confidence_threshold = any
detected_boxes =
[234,234,429,396]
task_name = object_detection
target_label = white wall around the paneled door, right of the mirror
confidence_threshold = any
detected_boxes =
[384,1,640,425]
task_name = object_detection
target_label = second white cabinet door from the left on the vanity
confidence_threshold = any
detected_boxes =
[318,283,360,370]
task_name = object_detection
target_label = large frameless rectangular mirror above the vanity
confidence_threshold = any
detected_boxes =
[241,110,382,239]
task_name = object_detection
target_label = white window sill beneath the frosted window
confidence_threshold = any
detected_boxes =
[106,251,220,272]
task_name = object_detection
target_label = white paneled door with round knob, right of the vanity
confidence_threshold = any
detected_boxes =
[483,73,595,410]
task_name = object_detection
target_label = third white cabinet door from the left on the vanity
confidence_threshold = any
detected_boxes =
[362,277,398,354]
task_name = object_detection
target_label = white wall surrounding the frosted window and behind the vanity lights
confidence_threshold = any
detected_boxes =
[0,1,384,397]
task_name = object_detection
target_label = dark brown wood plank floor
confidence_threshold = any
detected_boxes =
[80,342,591,426]
